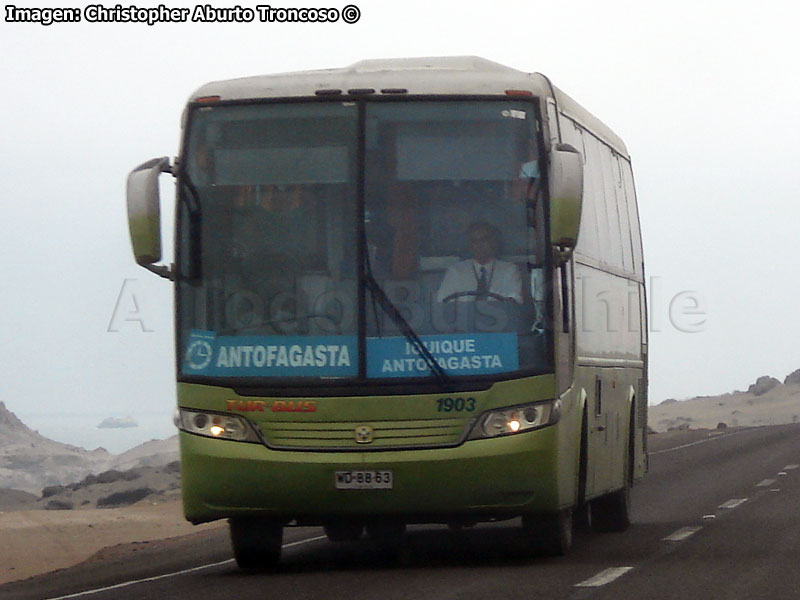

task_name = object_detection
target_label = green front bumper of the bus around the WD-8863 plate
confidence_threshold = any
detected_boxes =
[180,426,561,524]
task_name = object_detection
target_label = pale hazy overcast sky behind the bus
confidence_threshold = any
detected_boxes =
[0,0,800,452]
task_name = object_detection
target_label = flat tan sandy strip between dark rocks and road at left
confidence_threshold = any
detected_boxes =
[0,499,224,584]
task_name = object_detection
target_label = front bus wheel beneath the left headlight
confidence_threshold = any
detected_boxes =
[228,518,283,569]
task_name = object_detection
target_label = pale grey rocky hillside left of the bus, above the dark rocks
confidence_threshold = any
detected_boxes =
[0,402,178,496]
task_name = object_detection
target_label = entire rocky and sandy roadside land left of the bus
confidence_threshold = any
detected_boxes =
[0,403,198,584]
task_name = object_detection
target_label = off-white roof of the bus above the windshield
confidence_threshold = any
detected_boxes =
[191,56,628,157]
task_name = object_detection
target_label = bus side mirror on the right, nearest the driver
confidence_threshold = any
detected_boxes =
[550,144,583,261]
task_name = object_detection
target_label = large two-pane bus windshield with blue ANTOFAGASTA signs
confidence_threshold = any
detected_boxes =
[177,100,552,385]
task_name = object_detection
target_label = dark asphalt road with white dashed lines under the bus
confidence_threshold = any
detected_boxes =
[6,425,800,600]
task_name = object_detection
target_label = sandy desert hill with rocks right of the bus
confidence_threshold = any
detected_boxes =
[648,369,800,431]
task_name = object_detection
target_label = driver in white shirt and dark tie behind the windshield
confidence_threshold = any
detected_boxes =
[436,221,522,304]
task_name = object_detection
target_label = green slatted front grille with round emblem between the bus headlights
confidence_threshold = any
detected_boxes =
[259,418,473,452]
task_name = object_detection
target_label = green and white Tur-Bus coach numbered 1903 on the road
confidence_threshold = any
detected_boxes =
[127,57,647,568]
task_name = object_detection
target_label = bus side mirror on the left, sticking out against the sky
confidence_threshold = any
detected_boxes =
[127,156,172,278]
